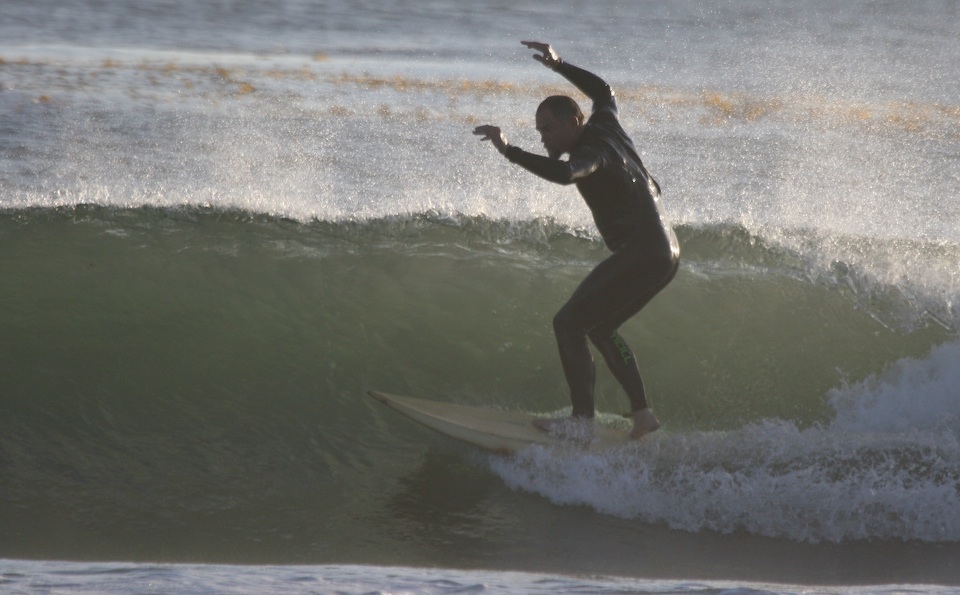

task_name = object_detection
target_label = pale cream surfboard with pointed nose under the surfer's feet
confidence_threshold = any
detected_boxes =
[369,391,629,454]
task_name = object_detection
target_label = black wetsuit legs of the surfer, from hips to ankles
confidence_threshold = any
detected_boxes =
[553,244,678,417]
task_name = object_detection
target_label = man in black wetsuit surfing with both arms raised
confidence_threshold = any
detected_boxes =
[473,41,680,438]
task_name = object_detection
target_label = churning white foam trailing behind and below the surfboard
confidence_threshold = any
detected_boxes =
[490,378,960,543]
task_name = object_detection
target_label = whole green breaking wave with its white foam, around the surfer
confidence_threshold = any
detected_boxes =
[0,206,960,555]
